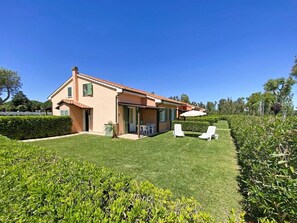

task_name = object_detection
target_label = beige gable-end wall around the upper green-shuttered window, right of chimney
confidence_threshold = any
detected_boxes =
[78,78,117,134]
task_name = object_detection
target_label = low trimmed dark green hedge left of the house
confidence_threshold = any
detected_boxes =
[0,116,72,139]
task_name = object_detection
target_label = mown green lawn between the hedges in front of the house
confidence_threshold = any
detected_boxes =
[31,121,241,220]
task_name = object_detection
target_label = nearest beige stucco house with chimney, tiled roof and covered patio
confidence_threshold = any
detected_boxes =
[49,67,183,135]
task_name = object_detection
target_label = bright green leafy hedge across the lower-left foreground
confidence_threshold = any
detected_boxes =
[0,136,247,222]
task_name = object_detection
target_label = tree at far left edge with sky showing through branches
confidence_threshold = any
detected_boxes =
[0,67,22,105]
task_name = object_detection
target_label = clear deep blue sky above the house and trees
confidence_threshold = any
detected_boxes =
[0,0,297,106]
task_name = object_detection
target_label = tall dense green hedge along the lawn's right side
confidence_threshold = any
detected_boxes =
[229,116,297,222]
